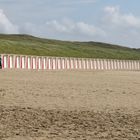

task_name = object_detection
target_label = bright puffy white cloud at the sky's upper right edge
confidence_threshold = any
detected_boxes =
[104,6,140,28]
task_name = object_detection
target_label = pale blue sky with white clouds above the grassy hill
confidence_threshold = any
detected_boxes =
[0,0,140,48]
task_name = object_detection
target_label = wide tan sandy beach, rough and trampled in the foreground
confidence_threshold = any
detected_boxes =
[0,70,140,140]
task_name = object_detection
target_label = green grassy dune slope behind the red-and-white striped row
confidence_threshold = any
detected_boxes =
[0,34,140,59]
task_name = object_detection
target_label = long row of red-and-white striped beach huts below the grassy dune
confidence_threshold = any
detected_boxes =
[0,54,140,70]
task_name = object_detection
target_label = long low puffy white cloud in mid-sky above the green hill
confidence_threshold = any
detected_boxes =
[46,19,105,37]
